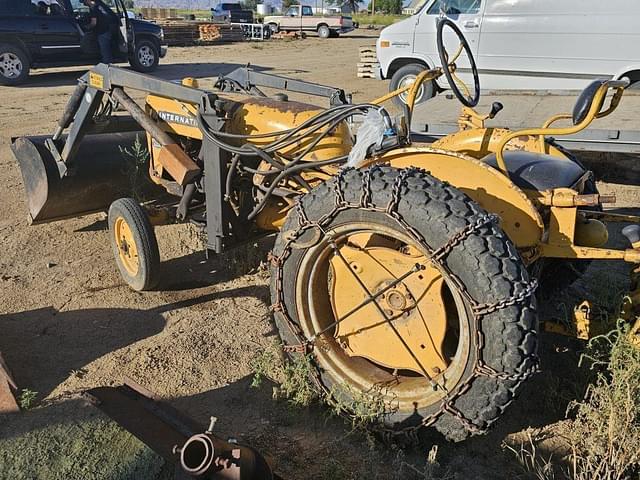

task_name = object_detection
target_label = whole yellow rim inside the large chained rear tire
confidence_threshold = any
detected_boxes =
[295,222,471,415]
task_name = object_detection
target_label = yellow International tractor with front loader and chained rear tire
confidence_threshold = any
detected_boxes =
[12,19,640,440]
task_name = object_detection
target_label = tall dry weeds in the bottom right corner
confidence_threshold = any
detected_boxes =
[505,318,640,480]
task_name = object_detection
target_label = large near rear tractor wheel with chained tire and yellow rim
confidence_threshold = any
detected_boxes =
[271,166,537,441]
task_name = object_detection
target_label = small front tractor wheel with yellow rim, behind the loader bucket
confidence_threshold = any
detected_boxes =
[109,198,160,291]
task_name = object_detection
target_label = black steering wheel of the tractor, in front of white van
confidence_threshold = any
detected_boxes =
[437,18,480,107]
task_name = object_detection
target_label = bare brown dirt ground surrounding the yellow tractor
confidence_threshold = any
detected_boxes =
[0,32,638,479]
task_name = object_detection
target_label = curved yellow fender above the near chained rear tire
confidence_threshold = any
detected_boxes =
[376,147,544,248]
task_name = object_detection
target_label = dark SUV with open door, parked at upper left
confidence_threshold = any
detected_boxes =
[0,0,167,85]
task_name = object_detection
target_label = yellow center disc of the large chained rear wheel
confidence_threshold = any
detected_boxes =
[331,238,448,376]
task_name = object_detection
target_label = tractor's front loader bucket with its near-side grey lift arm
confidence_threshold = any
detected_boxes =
[11,64,218,224]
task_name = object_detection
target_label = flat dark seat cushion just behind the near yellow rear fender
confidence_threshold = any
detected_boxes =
[482,150,585,190]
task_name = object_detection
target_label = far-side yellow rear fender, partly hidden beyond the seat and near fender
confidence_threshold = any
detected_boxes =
[431,128,566,158]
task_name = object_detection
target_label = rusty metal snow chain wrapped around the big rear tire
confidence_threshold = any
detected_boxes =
[269,165,539,439]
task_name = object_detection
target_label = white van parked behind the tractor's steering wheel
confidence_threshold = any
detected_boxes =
[377,0,640,101]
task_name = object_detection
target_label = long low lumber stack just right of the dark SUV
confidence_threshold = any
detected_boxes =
[158,20,244,46]
